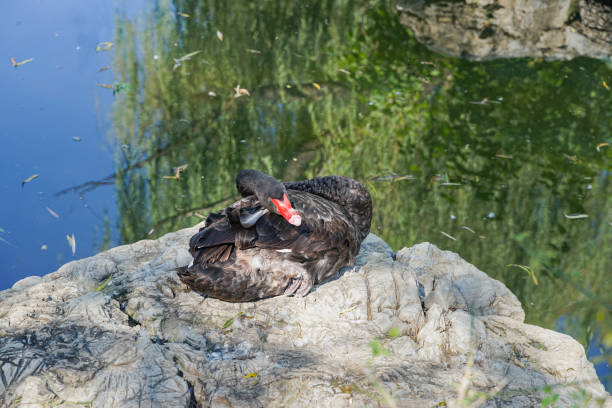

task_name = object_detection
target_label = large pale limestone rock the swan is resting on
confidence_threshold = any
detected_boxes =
[0,226,612,407]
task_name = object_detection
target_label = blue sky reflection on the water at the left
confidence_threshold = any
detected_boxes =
[0,0,143,290]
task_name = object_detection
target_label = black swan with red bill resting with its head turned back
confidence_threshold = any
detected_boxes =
[177,170,372,302]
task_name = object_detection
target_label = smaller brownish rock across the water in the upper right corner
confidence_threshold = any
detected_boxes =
[396,0,612,60]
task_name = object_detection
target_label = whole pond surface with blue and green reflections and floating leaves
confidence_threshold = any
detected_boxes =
[0,0,612,389]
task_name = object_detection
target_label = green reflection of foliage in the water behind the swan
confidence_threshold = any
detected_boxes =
[114,0,612,366]
